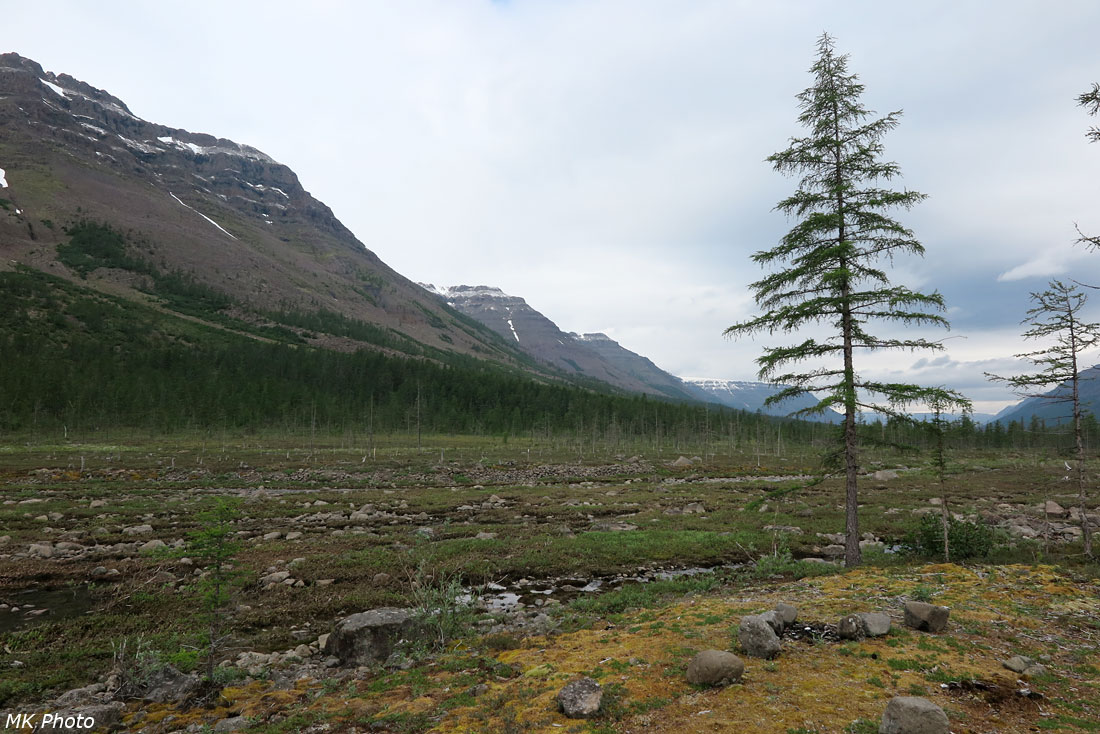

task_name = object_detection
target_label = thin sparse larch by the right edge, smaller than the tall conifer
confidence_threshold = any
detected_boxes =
[986,281,1100,557]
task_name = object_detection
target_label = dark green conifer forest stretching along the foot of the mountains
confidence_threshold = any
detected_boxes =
[0,222,1097,449]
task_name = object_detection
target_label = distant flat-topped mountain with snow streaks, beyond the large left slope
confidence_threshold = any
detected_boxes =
[420,283,703,401]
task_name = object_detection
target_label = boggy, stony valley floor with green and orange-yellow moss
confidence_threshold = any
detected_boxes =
[0,437,1100,734]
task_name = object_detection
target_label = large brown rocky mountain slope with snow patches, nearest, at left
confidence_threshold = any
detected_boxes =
[0,53,528,371]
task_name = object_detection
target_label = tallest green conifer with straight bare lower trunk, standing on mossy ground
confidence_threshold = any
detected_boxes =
[725,34,966,566]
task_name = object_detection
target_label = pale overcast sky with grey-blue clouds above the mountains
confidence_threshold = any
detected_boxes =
[0,0,1100,413]
